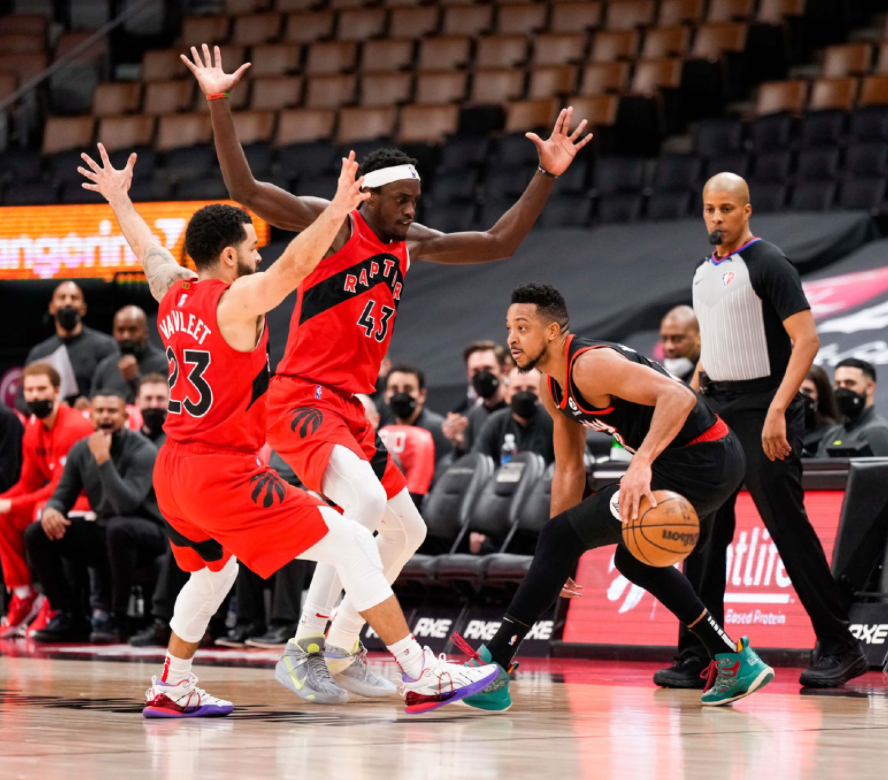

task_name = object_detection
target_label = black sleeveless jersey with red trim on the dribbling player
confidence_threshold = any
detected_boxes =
[546,336,727,452]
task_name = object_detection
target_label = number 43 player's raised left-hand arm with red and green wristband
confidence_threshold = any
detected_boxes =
[180,44,329,231]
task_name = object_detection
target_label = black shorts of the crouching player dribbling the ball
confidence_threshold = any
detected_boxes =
[567,432,746,549]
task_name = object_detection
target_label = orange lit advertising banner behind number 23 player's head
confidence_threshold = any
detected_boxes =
[0,201,270,280]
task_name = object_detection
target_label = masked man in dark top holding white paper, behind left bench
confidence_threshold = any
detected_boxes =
[15,282,116,414]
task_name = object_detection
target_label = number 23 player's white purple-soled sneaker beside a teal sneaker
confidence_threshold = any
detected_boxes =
[401,647,498,713]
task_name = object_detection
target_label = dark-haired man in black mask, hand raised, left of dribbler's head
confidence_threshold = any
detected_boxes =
[443,341,508,458]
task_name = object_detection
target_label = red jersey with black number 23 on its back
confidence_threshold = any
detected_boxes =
[157,279,269,452]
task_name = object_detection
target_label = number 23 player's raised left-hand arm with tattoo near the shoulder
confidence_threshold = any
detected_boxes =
[77,144,197,301]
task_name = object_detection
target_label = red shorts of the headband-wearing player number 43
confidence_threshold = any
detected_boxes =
[268,376,407,498]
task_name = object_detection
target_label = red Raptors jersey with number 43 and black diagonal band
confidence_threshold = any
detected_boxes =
[277,211,410,393]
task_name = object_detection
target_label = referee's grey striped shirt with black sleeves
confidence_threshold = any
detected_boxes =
[693,238,811,387]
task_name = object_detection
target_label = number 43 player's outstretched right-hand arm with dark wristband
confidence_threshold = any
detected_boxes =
[407,107,592,265]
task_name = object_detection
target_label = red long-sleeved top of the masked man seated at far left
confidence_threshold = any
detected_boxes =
[0,406,94,517]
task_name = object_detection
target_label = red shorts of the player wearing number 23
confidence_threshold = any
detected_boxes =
[154,439,327,579]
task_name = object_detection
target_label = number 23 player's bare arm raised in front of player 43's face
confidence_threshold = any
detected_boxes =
[219,152,370,322]
